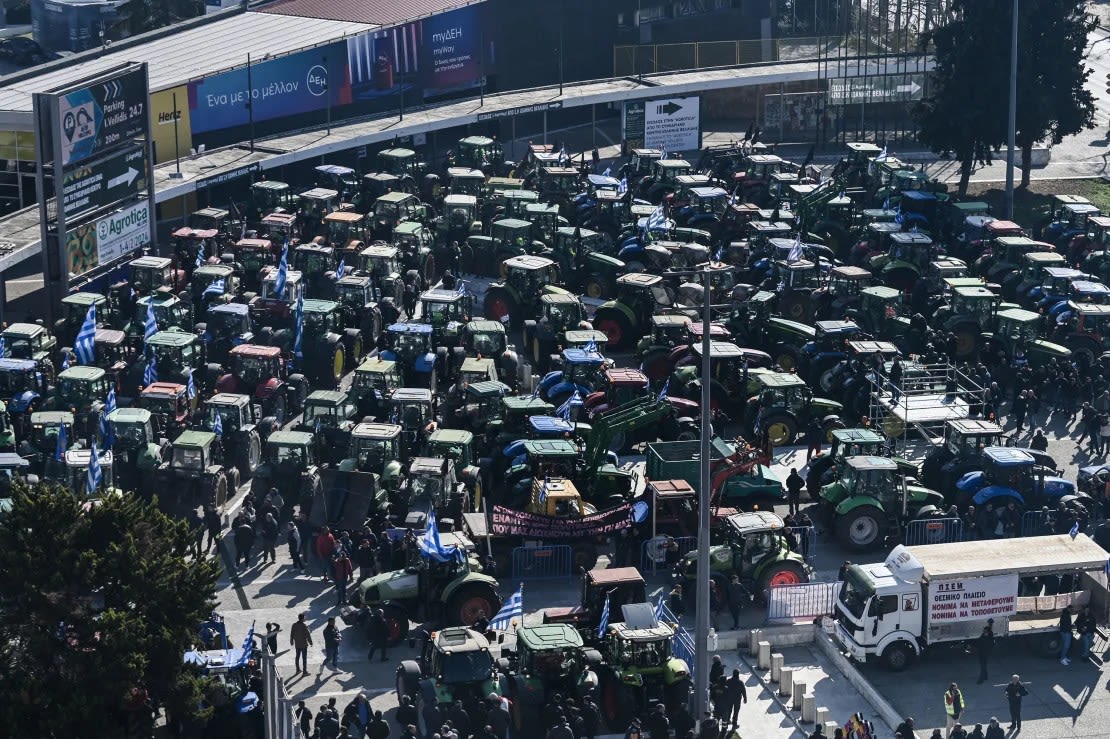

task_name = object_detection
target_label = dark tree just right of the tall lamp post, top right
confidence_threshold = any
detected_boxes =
[1007,0,1097,188]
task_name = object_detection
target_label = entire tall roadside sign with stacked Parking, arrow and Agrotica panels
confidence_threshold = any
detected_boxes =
[34,63,154,323]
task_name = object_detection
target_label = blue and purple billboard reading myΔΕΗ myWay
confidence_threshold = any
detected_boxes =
[347,3,493,100]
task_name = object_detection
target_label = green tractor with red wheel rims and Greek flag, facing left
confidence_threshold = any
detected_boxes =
[351,533,501,646]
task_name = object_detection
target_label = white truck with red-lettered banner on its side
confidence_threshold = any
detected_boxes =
[833,534,1110,671]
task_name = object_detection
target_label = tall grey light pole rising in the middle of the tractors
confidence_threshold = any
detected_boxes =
[694,263,713,722]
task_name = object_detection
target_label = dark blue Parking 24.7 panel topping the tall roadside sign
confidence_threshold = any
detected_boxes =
[58,68,149,166]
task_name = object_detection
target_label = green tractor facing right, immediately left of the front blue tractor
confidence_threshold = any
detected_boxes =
[820,456,945,551]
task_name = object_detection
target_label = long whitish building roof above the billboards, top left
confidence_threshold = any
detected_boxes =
[0,11,375,115]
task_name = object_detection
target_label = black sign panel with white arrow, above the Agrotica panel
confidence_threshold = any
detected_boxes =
[62,143,147,221]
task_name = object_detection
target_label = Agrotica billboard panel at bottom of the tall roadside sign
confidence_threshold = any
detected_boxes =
[62,200,151,280]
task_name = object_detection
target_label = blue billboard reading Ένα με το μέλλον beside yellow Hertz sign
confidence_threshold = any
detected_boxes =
[186,41,351,136]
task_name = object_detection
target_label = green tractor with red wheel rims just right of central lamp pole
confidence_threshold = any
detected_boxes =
[672,510,813,610]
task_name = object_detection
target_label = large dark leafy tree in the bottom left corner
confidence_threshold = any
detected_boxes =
[0,485,218,738]
